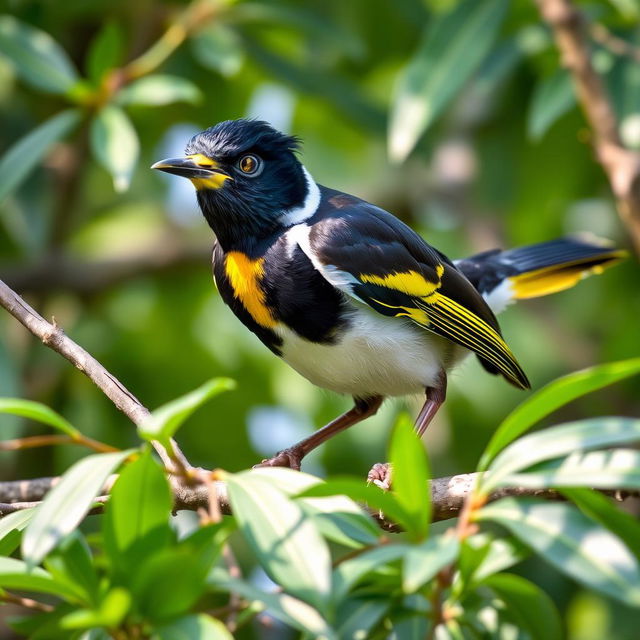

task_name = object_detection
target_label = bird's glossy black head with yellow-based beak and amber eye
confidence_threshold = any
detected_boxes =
[152,120,310,247]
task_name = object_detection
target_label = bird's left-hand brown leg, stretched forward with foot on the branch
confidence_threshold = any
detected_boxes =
[254,396,383,471]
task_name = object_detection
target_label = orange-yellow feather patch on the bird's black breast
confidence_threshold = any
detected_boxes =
[224,251,277,329]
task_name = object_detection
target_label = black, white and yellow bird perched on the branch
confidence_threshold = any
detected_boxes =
[151,119,625,482]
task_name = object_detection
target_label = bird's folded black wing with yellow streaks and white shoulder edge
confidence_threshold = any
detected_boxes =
[294,197,529,388]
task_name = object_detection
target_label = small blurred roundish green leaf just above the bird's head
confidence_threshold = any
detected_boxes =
[191,24,244,78]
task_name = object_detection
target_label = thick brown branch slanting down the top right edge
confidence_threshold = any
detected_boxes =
[536,0,640,253]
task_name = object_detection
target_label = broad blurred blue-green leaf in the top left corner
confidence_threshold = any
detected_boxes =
[0,15,78,93]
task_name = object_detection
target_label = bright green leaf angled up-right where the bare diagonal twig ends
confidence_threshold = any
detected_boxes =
[138,378,236,447]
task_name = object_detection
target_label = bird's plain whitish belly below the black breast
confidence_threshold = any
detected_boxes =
[276,307,467,397]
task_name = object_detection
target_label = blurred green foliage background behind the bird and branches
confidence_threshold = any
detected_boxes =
[0,0,640,640]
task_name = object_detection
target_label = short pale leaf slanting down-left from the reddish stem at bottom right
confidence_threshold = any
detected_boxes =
[402,533,460,593]
